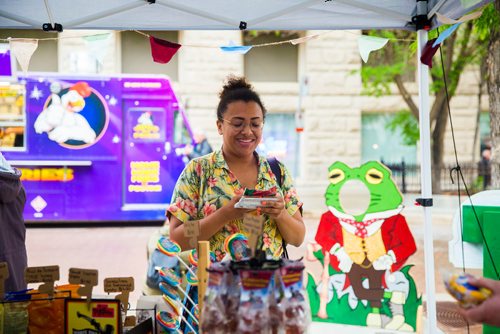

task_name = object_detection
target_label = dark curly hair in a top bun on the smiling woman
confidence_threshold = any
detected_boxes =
[217,76,267,121]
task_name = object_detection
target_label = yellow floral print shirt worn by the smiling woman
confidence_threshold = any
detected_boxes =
[167,150,302,261]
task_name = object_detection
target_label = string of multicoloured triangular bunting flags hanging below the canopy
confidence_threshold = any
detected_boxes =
[0,10,482,72]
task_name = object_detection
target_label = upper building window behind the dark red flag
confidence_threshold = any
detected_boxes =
[121,31,179,81]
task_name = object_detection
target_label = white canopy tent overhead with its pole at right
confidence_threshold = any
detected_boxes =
[0,0,491,333]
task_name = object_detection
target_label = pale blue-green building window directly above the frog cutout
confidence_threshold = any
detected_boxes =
[361,113,417,164]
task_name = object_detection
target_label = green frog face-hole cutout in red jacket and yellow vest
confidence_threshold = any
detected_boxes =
[307,161,421,331]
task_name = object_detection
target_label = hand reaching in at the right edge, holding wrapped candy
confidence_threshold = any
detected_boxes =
[459,278,500,326]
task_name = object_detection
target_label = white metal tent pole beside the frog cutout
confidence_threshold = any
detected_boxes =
[417,29,438,333]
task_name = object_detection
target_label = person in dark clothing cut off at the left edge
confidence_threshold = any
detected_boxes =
[0,152,28,291]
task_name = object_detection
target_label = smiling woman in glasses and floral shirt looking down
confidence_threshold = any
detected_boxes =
[167,77,305,258]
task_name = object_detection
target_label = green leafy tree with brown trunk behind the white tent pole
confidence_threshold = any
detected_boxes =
[361,5,492,192]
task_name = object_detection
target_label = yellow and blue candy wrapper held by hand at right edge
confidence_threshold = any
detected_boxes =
[443,273,491,308]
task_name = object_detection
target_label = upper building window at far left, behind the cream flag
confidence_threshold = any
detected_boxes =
[0,29,58,72]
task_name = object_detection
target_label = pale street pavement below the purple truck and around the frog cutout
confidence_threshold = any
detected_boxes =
[26,195,481,333]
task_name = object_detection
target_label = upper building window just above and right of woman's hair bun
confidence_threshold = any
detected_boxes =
[243,31,300,82]
